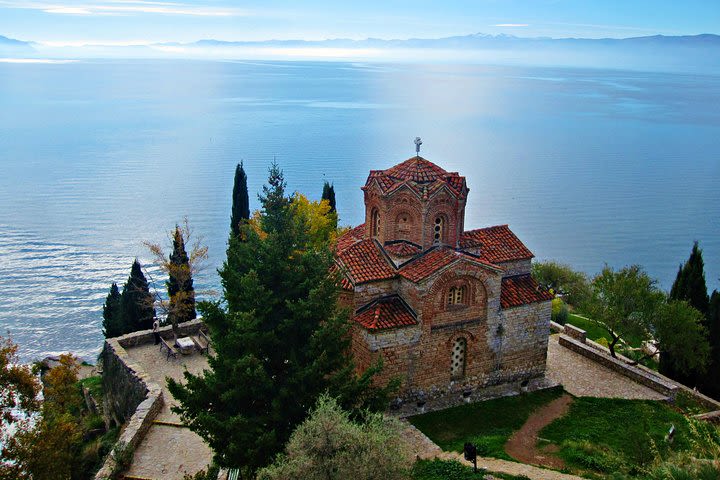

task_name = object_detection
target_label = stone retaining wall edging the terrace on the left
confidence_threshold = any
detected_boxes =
[95,319,203,480]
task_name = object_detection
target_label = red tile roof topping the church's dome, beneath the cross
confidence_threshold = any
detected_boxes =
[363,157,465,197]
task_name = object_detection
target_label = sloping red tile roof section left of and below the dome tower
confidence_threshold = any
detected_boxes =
[337,239,396,285]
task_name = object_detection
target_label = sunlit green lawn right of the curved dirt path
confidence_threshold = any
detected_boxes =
[539,397,694,475]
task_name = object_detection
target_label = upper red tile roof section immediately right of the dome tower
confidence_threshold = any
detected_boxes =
[460,225,534,263]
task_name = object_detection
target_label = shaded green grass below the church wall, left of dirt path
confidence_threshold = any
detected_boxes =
[408,387,563,460]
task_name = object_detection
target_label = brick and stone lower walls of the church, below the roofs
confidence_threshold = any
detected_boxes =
[353,262,551,405]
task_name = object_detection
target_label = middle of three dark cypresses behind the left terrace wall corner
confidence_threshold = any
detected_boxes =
[120,259,155,334]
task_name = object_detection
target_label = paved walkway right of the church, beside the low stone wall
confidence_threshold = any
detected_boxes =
[546,335,665,400]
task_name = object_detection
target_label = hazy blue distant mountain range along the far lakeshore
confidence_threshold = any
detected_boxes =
[0,33,720,72]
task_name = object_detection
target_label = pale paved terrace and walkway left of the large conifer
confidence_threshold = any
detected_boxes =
[126,345,212,480]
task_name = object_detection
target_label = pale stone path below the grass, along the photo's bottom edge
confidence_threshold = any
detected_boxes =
[403,421,583,480]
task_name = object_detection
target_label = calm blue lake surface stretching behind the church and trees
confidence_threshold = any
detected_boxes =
[0,61,720,360]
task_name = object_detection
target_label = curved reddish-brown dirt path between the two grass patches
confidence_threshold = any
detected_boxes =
[505,394,573,470]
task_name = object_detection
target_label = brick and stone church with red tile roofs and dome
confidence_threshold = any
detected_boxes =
[335,154,553,410]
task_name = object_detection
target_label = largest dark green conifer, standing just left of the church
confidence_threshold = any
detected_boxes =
[168,164,394,473]
